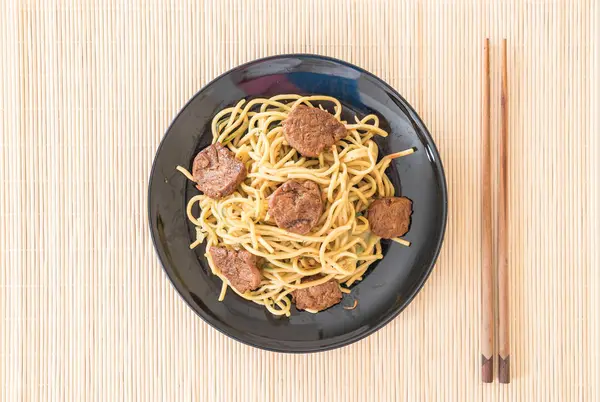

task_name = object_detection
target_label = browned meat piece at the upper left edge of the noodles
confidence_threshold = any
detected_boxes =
[192,143,247,199]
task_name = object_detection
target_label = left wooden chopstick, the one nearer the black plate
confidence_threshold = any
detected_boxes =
[481,38,494,383]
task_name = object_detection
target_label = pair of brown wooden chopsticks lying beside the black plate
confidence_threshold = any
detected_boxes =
[481,39,510,384]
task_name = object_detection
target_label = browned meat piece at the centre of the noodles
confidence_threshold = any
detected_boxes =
[269,180,323,234]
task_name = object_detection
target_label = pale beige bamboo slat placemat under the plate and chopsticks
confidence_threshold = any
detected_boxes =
[0,0,600,402]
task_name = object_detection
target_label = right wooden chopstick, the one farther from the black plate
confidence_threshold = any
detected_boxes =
[498,39,510,384]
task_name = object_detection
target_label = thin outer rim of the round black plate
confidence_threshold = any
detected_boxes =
[148,53,448,354]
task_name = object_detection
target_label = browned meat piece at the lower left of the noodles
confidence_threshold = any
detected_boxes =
[209,247,262,293]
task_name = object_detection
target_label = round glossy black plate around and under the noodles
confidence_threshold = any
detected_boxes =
[148,55,447,352]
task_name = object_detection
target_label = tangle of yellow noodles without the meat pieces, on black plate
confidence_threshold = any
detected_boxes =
[177,95,413,316]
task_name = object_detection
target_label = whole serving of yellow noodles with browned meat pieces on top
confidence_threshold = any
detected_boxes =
[177,94,414,316]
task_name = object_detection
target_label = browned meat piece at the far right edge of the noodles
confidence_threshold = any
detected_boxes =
[367,197,412,239]
